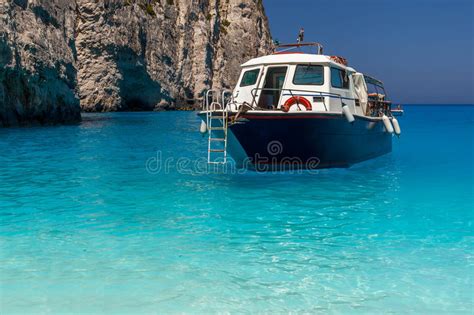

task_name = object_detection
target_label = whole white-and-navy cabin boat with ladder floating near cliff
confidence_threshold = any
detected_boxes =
[198,43,401,170]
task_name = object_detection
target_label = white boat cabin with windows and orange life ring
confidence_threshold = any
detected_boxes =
[233,45,385,115]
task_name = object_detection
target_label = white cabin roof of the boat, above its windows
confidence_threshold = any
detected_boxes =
[242,53,356,72]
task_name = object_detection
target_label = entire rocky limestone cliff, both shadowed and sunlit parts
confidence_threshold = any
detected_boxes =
[0,0,272,125]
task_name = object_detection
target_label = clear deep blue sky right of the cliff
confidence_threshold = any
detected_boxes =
[264,0,474,104]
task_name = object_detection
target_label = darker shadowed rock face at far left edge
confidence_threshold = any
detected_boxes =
[0,0,80,126]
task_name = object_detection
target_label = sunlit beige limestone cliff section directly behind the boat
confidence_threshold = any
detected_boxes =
[76,0,272,111]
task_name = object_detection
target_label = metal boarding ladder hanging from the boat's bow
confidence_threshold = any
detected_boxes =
[205,90,229,164]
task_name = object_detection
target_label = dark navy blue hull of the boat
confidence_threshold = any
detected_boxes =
[198,113,392,169]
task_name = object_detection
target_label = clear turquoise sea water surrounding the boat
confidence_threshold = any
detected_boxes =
[0,106,474,314]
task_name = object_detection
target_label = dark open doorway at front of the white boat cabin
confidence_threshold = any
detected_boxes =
[258,67,288,109]
